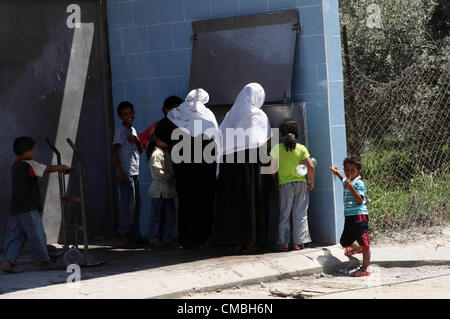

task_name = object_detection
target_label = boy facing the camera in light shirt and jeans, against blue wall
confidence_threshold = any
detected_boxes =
[112,101,142,248]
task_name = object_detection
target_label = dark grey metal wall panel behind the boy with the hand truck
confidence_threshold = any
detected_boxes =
[0,0,115,246]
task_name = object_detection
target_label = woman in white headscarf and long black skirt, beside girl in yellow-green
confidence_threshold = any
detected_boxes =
[215,83,271,251]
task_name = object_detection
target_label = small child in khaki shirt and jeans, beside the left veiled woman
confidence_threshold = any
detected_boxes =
[147,132,177,246]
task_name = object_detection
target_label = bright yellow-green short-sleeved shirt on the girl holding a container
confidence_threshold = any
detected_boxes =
[270,143,309,185]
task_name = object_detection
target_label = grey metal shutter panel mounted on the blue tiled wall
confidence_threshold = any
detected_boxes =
[190,10,299,106]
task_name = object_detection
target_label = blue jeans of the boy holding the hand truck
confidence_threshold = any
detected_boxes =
[3,210,50,264]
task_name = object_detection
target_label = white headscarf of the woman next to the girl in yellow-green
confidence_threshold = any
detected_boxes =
[219,83,272,154]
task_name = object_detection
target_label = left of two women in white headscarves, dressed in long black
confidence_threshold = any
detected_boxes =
[155,89,219,248]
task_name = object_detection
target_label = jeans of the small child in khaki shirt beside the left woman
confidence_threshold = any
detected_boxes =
[149,198,176,244]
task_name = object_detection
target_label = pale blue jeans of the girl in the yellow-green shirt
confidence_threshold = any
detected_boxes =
[277,182,311,244]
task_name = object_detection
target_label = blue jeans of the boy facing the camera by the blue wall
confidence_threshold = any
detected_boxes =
[117,175,141,237]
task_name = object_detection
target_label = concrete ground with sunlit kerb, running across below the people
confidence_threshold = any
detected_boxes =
[0,226,450,299]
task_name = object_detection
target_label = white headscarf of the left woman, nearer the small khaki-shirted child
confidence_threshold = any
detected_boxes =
[167,89,219,138]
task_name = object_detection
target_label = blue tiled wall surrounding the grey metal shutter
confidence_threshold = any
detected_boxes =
[107,0,347,243]
